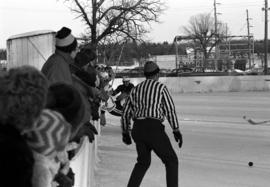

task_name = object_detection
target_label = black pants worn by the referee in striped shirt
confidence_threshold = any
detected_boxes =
[128,118,178,187]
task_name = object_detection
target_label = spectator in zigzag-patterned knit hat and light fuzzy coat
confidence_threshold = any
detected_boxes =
[25,109,71,187]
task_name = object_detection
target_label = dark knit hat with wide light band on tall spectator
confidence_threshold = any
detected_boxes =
[55,27,77,53]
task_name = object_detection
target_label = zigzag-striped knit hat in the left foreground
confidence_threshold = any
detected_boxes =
[25,109,71,156]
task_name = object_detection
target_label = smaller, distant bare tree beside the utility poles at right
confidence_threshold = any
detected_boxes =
[183,14,227,62]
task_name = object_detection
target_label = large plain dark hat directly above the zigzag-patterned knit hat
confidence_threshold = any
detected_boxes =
[46,82,85,132]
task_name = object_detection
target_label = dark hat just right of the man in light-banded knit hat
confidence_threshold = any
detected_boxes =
[75,48,97,67]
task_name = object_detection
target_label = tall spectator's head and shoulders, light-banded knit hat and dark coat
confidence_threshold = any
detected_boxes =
[41,27,79,84]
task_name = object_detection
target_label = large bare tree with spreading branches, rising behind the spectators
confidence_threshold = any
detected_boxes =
[63,0,165,49]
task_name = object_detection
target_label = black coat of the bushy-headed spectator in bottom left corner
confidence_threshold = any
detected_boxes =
[0,124,34,187]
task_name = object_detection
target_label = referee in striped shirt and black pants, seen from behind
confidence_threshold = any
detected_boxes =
[121,61,183,187]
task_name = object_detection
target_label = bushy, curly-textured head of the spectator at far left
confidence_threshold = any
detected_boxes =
[0,65,48,131]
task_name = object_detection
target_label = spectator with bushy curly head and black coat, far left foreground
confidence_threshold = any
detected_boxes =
[0,66,48,187]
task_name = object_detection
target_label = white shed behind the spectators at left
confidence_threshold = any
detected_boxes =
[7,30,56,70]
